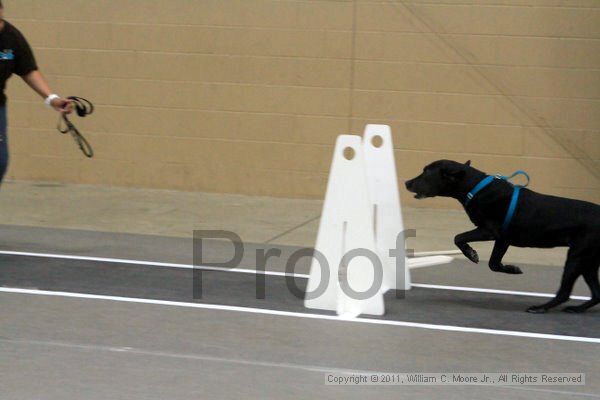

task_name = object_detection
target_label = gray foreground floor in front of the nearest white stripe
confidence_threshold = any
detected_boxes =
[0,294,600,400]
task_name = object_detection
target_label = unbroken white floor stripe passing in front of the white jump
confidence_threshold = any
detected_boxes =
[0,287,600,343]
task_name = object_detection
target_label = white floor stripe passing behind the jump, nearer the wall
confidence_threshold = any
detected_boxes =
[0,250,590,300]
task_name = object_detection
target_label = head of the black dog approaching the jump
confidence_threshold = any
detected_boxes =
[406,160,473,199]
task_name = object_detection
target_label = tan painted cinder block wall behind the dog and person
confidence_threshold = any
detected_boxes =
[4,0,600,207]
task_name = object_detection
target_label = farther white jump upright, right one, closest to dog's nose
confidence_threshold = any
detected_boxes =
[363,125,410,291]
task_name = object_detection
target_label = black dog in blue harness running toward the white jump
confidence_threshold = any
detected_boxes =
[406,160,600,313]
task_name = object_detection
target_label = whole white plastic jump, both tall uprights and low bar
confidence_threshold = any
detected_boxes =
[304,125,452,317]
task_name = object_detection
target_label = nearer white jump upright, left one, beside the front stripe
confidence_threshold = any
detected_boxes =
[304,135,385,316]
